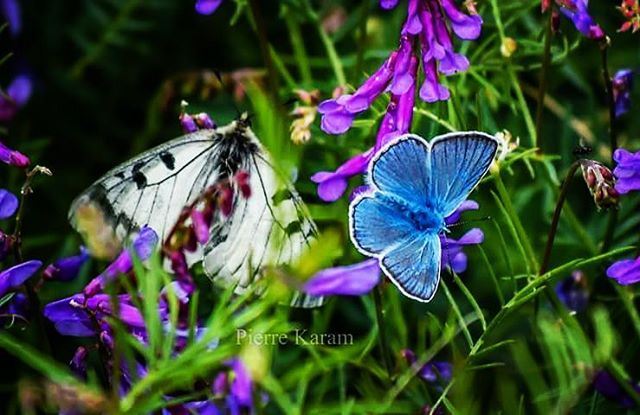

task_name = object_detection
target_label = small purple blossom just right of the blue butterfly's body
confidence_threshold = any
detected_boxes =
[440,200,484,274]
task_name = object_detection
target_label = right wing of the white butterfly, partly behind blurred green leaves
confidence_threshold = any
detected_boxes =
[204,136,323,307]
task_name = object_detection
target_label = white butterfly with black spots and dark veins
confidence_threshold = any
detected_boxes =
[69,115,322,307]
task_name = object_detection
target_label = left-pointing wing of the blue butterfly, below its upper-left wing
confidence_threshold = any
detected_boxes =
[350,192,424,255]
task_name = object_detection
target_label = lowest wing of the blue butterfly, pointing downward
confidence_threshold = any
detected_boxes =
[380,233,442,302]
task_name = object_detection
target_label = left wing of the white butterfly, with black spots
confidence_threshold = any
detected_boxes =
[69,130,219,259]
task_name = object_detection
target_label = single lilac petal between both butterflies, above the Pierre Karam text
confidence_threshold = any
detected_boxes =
[302,258,380,295]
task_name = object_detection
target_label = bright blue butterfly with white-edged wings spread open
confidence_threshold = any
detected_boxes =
[349,132,499,302]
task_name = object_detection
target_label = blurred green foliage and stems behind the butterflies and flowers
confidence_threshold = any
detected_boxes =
[0,0,640,414]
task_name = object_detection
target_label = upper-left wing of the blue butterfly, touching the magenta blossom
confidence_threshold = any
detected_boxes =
[370,135,431,205]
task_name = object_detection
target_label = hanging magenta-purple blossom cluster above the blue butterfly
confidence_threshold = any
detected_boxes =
[311,0,482,202]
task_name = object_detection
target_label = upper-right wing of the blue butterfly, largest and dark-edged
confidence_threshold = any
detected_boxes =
[428,132,498,217]
